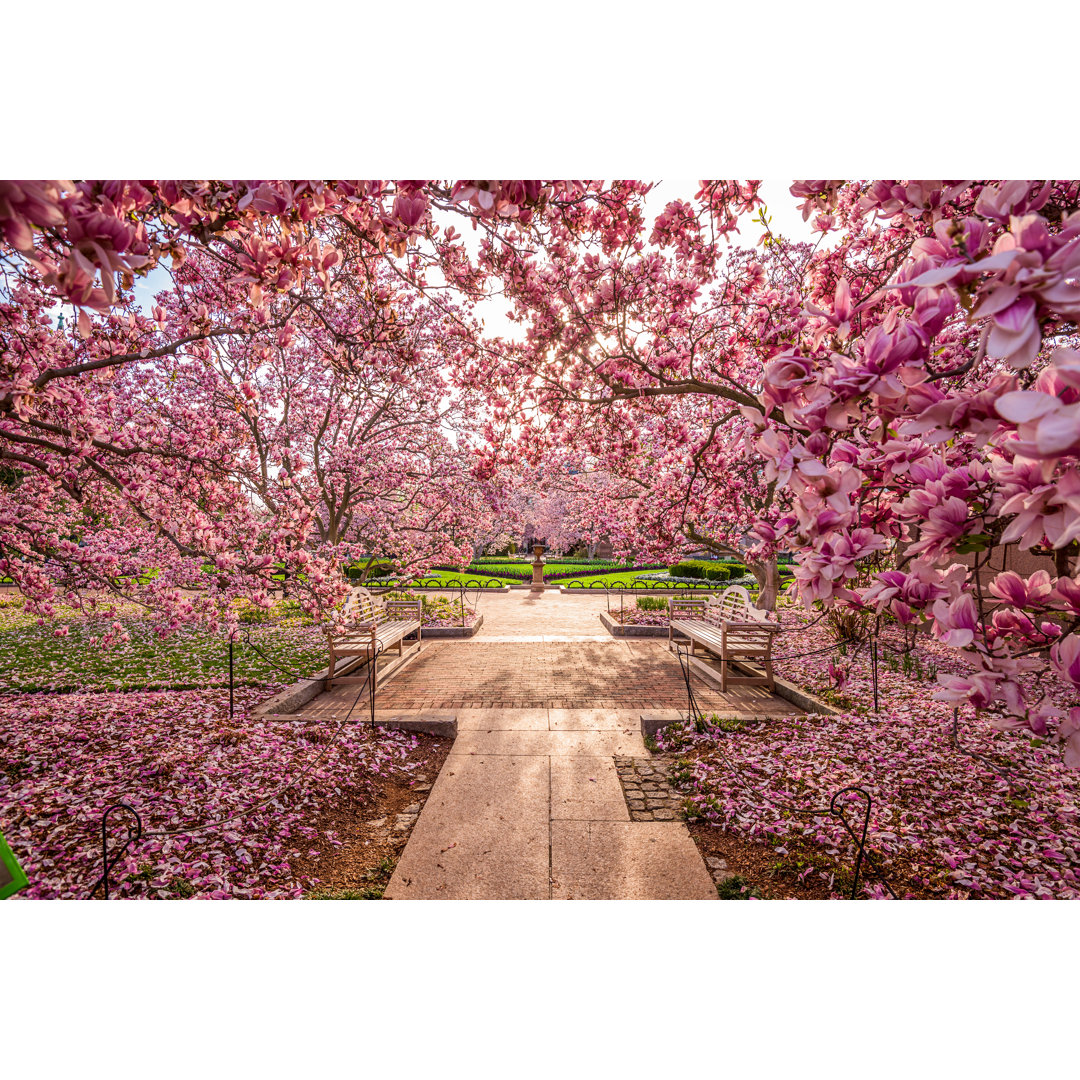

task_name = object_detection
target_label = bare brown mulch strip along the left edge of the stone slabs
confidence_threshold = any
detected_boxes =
[295,734,454,900]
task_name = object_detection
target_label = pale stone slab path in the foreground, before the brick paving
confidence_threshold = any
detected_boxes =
[386,708,716,900]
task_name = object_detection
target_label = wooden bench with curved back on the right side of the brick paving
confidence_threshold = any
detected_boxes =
[667,585,780,693]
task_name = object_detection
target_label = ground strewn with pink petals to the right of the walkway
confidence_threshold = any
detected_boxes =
[658,608,1080,899]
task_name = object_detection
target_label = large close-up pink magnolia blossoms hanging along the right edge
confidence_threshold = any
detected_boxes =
[747,181,1080,765]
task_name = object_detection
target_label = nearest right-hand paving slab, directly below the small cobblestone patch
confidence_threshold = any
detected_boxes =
[551,821,717,900]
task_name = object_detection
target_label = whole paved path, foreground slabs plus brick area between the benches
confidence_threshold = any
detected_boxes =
[303,591,792,900]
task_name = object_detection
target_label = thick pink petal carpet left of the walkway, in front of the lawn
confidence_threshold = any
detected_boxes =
[0,687,421,899]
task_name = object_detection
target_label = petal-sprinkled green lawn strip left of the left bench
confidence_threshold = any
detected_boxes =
[0,611,326,692]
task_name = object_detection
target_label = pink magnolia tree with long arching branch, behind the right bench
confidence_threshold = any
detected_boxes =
[472,183,810,607]
